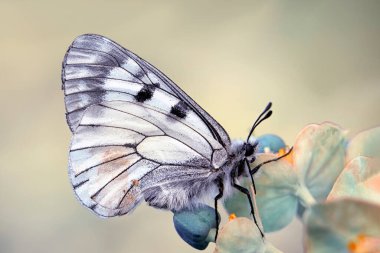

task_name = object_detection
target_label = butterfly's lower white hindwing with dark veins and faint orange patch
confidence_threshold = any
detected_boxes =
[69,101,226,216]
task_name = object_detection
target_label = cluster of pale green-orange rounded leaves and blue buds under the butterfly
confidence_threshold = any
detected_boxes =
[174,123,380,253]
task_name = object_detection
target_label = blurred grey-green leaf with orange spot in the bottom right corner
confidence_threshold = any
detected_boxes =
[304,198,380,253]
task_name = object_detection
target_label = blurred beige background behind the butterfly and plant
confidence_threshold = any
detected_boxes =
[0,0,380,253]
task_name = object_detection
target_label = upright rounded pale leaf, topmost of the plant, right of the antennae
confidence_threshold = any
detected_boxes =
[293,123,346,201]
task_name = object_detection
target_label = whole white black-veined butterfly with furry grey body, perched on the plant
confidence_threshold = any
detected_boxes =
[62,34,288,239]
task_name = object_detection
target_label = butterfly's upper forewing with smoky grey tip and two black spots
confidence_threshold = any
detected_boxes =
[62,34,230,147]
